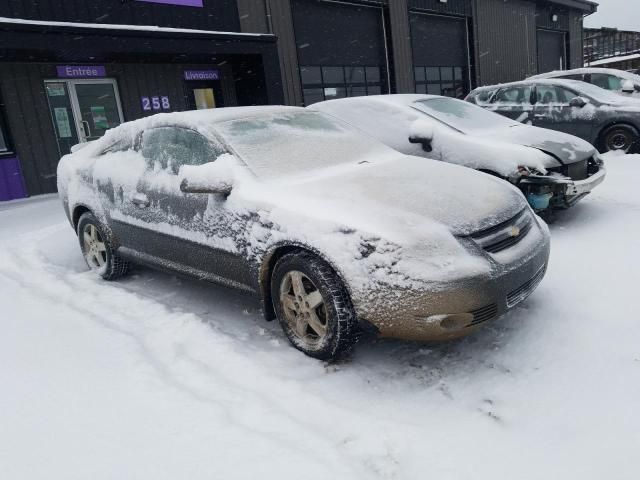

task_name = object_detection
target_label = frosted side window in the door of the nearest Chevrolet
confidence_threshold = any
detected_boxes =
[141,127,224,175]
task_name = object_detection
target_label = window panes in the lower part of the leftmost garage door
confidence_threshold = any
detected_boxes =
[300,66,382,105]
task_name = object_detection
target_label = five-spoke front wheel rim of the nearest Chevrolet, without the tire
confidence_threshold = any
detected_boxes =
[280,270,328,347]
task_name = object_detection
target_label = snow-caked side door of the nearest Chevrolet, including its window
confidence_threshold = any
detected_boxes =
[119,126,252,289]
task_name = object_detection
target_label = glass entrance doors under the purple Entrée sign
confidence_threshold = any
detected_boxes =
[45,79,123,156]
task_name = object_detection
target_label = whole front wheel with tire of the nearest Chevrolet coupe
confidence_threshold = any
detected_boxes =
[271,252,358,360]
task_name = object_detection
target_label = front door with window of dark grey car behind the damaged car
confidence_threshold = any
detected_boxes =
[533,84,595,141]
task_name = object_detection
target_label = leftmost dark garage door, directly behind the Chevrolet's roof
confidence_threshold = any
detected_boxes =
[292,0,388,105]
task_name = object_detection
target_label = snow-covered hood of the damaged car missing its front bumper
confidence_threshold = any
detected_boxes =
[477,125,596,168]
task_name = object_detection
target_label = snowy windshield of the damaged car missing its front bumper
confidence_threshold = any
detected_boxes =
[413,98,520,133]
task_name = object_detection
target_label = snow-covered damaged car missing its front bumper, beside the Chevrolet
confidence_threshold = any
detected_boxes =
[307,95,606,213]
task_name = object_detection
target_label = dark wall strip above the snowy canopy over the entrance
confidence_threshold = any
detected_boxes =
[0,0,240,32]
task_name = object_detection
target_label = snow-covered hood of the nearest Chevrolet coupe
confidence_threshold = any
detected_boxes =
[287,155,527,235]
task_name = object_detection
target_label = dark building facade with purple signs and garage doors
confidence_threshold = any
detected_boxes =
[0,0,596,200]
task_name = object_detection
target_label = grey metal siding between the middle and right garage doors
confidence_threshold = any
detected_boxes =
[474,0,537,85]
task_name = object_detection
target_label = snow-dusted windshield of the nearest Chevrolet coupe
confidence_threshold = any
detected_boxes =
[218,111,394,179]
